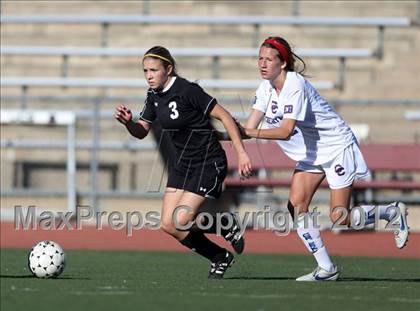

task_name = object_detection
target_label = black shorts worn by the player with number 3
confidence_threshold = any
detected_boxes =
[166,155,227,199]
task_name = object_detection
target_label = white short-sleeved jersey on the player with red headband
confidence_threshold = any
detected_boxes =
[252,71,357,165]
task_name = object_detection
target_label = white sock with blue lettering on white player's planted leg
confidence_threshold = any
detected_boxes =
[297,214,334,271]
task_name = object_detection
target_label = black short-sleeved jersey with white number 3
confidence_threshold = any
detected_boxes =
[140,77,224,163]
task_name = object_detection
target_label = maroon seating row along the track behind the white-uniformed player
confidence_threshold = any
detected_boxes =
[224,142,420,204]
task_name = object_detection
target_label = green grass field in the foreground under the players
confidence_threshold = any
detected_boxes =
[1,249,420,311]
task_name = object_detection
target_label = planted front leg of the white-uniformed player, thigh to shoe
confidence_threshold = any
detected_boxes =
[289,171,338,281]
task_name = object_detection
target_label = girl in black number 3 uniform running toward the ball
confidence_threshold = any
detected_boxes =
[115,46,251,278]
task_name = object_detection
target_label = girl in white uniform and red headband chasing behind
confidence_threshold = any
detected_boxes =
[242,37,408,281]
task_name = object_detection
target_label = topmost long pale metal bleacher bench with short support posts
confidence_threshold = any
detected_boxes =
[1,15,414,53]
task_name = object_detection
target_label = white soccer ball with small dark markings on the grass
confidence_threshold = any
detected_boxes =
[28,241,66,278]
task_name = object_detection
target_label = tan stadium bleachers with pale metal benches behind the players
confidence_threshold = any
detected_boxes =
[1,1,420,224]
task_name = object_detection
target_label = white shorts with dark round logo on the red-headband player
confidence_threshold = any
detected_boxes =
[296,143,371,189]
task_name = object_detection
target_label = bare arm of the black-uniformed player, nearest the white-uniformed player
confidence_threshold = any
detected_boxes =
[210,103,252,177]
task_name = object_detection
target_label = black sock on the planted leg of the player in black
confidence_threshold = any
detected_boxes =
[180,232,226,262]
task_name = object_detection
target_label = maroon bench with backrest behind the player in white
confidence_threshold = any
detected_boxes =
[225,141,420,203]
